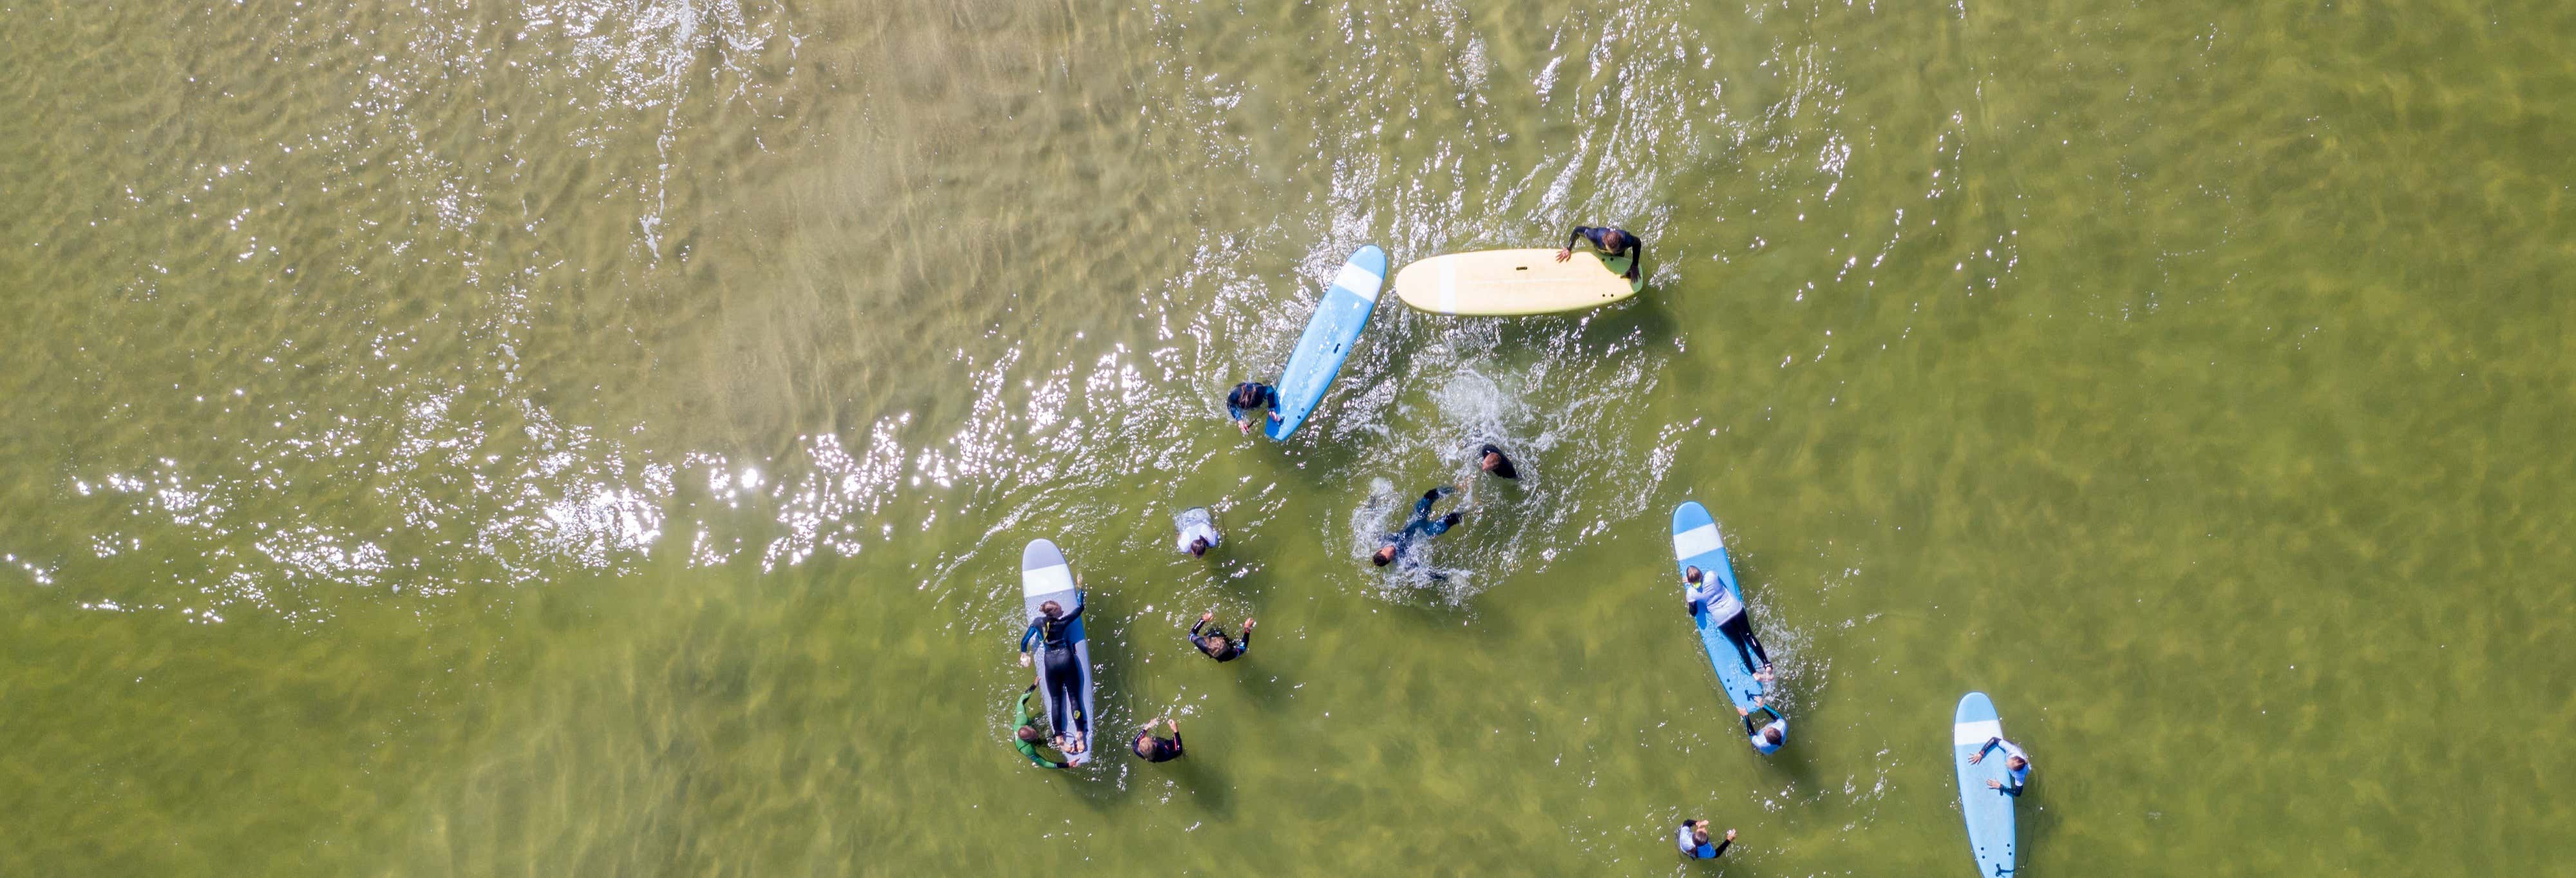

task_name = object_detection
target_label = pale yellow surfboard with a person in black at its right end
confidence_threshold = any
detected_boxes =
[1396,250,1646,317]
